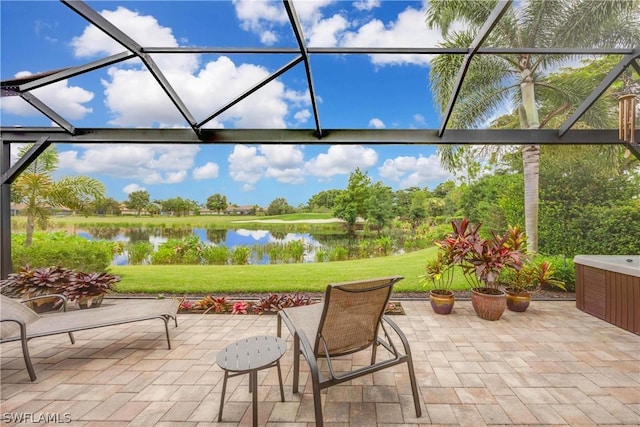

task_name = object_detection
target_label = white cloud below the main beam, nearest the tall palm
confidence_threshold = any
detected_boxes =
[378,154,453,188]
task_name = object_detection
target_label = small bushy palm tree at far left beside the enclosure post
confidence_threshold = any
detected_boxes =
[11,145,106,246]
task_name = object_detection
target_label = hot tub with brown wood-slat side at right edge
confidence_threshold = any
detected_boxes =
[573,255,640,334]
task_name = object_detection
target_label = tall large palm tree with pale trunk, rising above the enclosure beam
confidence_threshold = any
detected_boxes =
[427,0,640,253]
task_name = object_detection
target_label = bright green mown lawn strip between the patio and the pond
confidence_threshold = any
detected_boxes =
[110,247,466,295]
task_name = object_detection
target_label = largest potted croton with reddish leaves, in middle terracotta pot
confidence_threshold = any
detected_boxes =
[438,218,523,320]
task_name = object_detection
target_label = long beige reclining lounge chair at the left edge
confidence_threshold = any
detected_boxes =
[0,295,179,381]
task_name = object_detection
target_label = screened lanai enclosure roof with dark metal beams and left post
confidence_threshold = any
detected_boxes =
[0,0,640,278]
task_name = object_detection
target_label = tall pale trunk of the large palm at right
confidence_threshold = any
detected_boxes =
[520,65,540,254]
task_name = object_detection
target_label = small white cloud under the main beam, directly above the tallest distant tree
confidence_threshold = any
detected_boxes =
[305,145,378,178]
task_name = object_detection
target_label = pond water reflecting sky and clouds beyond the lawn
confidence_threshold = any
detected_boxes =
[73,228,353,265]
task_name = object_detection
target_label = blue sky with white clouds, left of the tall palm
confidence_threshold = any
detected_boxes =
[0,0,460,206]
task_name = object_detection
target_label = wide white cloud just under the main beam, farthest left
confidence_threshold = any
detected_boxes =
[58,144,200,184]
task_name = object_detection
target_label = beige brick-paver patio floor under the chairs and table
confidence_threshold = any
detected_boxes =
[0,301,640,427]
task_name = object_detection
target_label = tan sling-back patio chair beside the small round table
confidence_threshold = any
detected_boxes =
[277,276,422,426]
